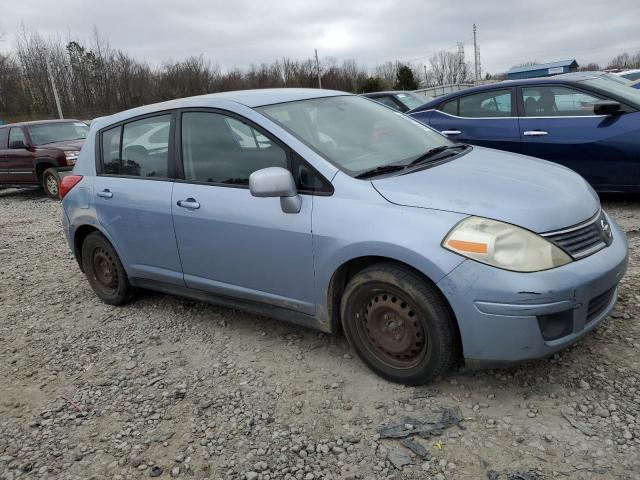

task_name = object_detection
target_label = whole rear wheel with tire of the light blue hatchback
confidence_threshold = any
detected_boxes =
[82,232,132,305]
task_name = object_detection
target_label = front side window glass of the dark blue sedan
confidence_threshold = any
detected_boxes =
[522,86,600,117]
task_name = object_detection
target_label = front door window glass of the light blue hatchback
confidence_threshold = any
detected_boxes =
[182,112,287,185]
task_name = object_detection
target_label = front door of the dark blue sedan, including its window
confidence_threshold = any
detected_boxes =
[518,84,640,190]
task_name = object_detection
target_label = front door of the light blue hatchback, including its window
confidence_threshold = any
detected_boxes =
[172,110,315,314]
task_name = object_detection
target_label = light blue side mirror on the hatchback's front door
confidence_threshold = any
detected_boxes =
[249,167,302,213]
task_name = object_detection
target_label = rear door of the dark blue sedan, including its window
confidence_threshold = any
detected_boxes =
[414,88,520,152]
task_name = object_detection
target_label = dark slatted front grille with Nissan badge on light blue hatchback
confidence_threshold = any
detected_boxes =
[542,211,612,260]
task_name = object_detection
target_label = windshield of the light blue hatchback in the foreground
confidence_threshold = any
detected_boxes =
[257,95,452,176]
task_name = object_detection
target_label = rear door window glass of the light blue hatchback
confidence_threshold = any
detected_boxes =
[102,115,171,178]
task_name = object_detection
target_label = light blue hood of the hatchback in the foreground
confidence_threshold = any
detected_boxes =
[372,147,600,233]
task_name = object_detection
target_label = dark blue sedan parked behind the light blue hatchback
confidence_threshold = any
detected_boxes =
[408,73,640,192]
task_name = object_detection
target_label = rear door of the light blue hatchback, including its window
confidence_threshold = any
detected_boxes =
[93,113,184,286]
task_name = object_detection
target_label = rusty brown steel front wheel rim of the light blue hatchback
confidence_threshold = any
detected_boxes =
[357,291,428,369]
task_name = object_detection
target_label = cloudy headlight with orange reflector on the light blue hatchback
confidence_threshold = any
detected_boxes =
[442,217,571,272]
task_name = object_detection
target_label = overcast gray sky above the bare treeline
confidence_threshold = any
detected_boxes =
[0,0,640,72]
